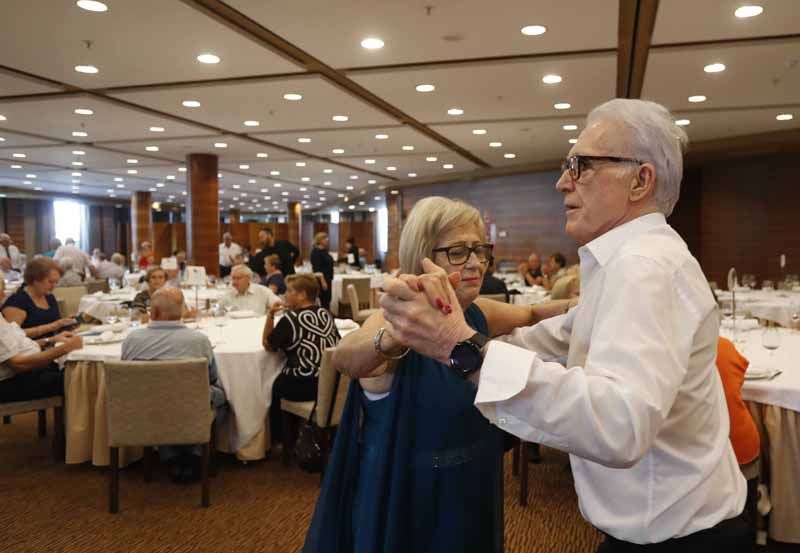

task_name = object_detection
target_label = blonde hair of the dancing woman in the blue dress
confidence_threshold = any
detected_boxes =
[399,196,486,275]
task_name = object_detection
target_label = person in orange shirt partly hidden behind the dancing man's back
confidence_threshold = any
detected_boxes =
[717,337,761,522]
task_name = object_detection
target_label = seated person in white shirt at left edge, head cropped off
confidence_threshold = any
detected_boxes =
[0,316,83,403]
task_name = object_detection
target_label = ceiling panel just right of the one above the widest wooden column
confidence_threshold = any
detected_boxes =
[255,126,444,159]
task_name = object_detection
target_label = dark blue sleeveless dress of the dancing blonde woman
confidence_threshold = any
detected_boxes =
[303,304,503,553]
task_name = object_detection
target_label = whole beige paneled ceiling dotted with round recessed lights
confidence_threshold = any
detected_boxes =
[0,0,800,211]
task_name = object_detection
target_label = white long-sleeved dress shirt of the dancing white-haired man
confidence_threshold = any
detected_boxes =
[475,214,746,544]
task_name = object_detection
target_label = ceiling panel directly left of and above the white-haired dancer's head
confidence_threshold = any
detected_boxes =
[349,55,617,124]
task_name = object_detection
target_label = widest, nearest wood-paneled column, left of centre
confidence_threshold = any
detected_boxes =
[186,154,220,275]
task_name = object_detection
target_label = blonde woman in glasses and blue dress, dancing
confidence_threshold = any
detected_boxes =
[303,197,569,553]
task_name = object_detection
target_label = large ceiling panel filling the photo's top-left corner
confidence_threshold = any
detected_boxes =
[0,0,298,88]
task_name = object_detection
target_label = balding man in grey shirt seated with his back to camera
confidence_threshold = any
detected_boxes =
[122,287,225,483]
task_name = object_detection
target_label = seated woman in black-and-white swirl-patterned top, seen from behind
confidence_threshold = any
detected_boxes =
[262,274,339,441]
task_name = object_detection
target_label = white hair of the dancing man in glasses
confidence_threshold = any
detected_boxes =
[586,98,689,216]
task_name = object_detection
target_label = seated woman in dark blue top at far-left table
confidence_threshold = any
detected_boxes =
[2,257,75,338]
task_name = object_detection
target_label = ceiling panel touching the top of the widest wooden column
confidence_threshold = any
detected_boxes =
[101,135,297,163]
